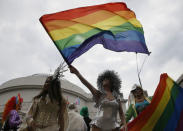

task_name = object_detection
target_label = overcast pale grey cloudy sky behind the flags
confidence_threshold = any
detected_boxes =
[0,0,183,98]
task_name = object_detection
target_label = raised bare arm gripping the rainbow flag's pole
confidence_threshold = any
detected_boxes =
[69,65,98,95]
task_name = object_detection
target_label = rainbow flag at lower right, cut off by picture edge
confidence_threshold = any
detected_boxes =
[122,74,183,131]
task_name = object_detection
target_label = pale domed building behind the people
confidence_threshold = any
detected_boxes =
[0,74,126,127]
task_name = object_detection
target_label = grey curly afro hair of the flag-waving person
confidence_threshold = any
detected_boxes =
[97,70,122,94]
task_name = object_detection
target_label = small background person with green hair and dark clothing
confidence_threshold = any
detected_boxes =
[80,106,91,131]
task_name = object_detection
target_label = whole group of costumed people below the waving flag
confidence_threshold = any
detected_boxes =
[2,66,151,131]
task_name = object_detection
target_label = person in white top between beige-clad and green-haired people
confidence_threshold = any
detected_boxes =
[67,103,87,131]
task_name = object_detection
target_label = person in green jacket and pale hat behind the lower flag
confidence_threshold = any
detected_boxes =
[125,84,152,122]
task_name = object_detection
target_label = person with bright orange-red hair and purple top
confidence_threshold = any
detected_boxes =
[2,94,23,131]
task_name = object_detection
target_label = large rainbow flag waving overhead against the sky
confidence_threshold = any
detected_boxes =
[40,2,150,64]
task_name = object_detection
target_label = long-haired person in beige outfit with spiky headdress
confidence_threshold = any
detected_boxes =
[22,65,68,131]
